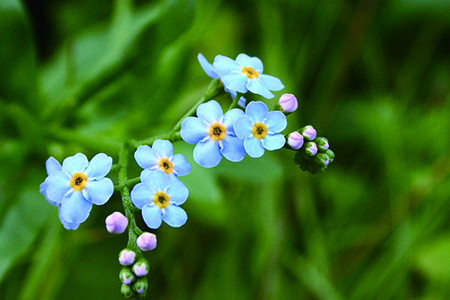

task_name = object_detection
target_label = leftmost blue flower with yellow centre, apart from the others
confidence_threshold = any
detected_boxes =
[41,153,114,229]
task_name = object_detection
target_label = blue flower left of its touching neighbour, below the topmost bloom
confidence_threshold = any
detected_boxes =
[180,100,245,168]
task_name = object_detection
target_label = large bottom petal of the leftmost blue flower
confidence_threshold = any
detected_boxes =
[61,191,92,223]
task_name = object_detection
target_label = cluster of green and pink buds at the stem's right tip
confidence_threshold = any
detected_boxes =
[288,125,334,174]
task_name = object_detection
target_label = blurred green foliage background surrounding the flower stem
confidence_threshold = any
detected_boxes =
[0,0,450,300]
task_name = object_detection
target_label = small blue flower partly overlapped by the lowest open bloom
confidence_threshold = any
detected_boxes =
[134,140,192,179]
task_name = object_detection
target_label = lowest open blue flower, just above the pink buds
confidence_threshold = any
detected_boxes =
[130,169,189,229]
